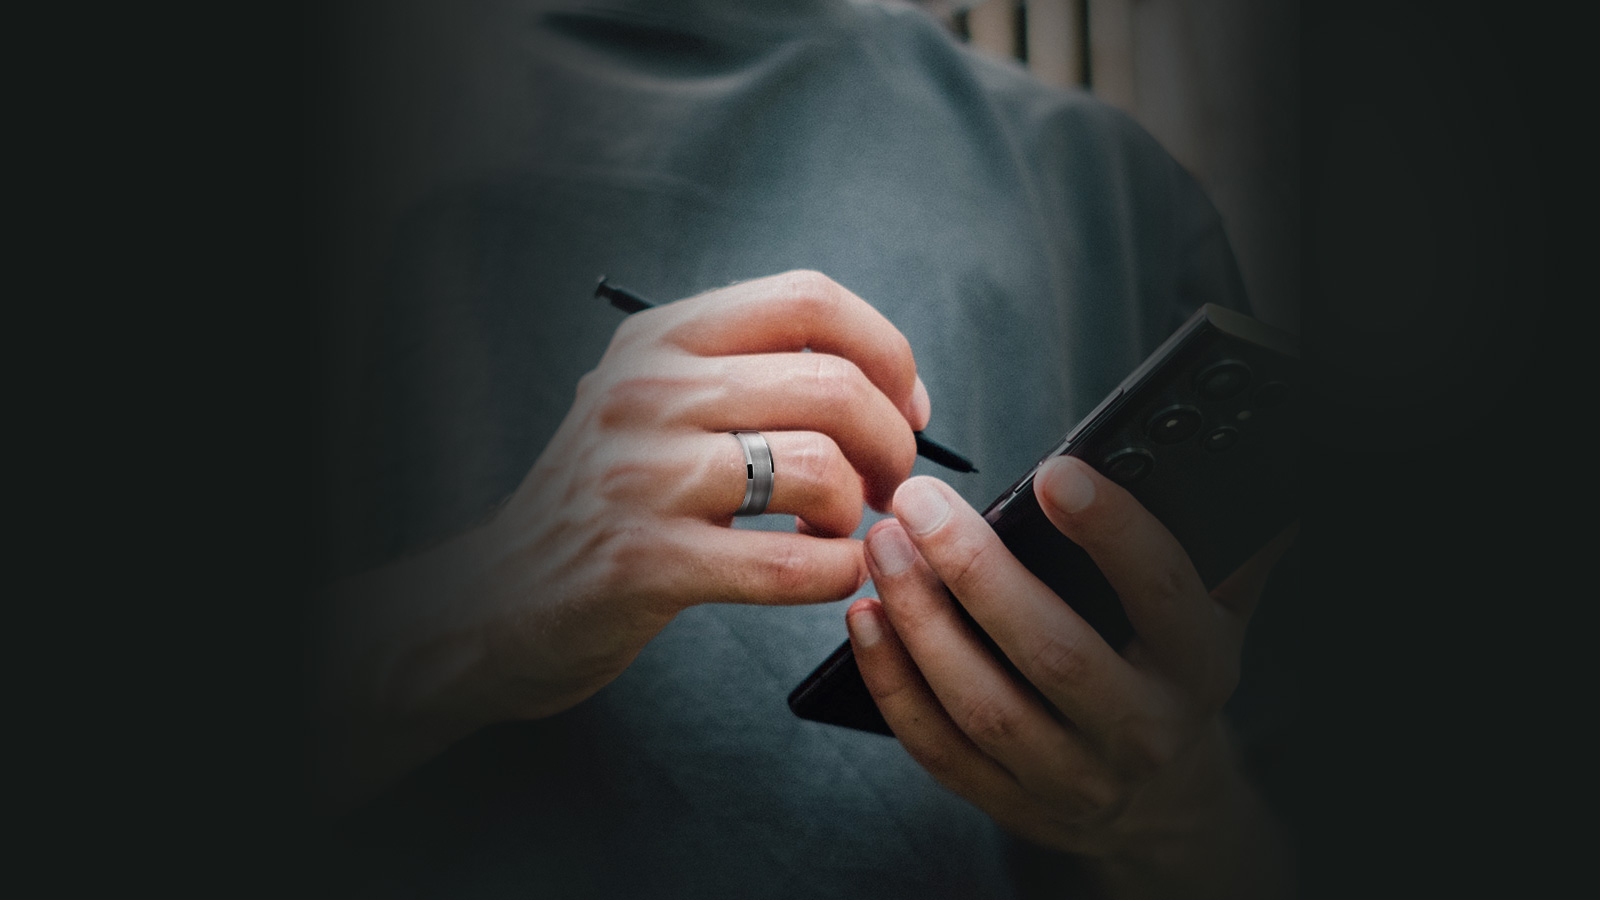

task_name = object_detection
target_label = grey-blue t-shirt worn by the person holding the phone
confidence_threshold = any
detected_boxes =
[318,0,1273,898]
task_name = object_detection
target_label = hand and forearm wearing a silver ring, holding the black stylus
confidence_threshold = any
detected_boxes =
[310,272,930,806]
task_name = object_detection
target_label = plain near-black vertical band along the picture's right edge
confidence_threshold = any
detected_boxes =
[1299,2,1594,897]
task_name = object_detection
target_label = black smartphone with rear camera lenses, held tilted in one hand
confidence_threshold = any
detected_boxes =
[789,304,1299,733]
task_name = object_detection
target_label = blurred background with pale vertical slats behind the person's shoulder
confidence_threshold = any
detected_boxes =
[918,0,1301,331]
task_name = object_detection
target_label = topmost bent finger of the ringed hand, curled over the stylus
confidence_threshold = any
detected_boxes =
[652,271,930,431]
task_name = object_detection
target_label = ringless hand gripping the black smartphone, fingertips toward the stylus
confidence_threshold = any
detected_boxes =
[848,458,1293,897]
